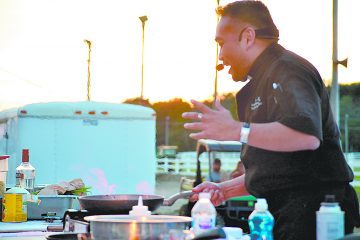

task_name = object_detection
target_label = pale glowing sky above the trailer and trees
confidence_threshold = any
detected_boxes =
[0,0,360,110]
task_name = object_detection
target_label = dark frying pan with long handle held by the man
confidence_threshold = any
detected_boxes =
[79,191,192,214]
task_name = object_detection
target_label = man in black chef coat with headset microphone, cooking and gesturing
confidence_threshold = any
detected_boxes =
[183,1,360,240]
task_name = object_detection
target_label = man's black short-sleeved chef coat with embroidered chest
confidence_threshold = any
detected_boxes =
[236,43,353,197]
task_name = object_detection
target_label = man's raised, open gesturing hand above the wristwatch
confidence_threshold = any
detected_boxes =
[182,99,241,141]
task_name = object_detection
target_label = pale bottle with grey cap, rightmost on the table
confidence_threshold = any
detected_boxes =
[316,195,344,240]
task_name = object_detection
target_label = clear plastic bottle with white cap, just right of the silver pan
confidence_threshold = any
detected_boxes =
[191,192,216,235]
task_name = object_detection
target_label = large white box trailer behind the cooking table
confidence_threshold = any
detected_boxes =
[0,101,156,194]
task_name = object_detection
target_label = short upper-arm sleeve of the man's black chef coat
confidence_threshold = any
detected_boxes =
[272,63,323,141]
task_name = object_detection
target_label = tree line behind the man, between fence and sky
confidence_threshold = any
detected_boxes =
[124,83,360,152]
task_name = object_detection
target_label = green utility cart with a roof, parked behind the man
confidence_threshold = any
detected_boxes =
[187,139,256,232]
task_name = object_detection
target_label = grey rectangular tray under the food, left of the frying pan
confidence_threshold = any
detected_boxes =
[27,195,80,219]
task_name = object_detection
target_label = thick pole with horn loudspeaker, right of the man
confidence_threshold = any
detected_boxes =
[330,0,348,125]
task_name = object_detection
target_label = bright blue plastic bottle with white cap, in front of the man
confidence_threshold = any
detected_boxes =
[249,198,274,240]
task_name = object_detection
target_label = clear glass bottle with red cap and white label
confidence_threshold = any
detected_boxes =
[16,149,35,193]
